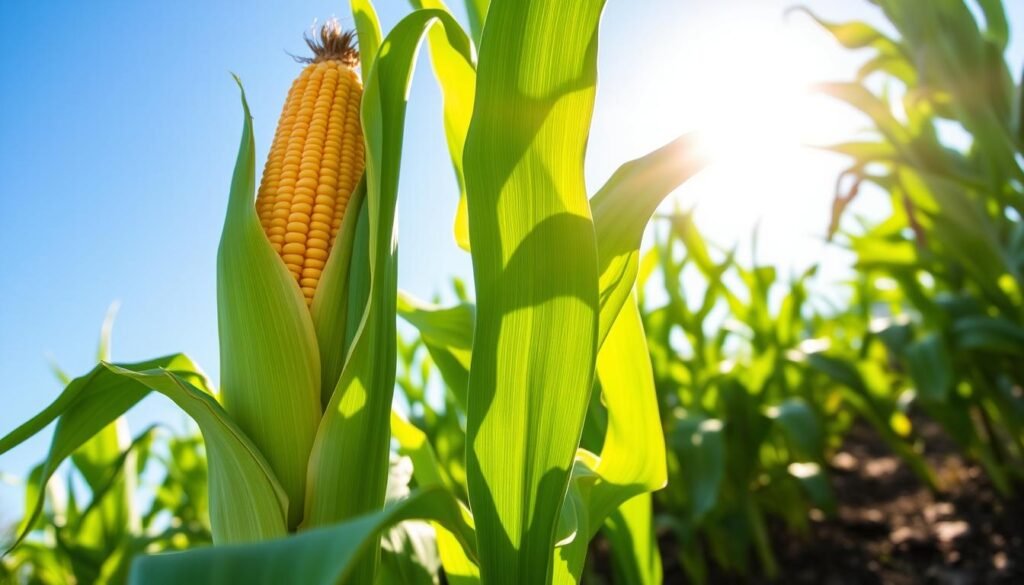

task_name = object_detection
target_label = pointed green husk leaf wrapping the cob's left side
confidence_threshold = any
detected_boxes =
[217,78,321,527]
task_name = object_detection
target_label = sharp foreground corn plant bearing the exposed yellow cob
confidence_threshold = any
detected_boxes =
[0,0,700,585]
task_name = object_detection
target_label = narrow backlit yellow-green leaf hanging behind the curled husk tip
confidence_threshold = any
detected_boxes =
[411,0,475,251]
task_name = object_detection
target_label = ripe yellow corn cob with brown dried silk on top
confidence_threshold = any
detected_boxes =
[256,20,365,305]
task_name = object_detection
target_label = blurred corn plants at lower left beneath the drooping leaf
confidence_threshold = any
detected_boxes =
[0,305,211,584]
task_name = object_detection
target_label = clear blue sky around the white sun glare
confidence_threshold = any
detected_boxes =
[0,0,1024,523]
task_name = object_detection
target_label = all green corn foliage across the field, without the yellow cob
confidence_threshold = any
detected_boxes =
[0,0,1024,584]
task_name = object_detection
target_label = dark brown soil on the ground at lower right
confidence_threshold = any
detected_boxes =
[659,421,1024,585]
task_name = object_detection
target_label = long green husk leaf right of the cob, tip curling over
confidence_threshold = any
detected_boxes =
[304,10,472,582]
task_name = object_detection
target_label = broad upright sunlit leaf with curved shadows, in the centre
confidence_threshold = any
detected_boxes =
[465,0,603,585]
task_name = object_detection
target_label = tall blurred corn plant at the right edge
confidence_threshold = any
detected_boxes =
[798,0,1024,494]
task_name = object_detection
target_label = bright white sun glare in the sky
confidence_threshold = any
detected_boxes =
[602,3,865,260]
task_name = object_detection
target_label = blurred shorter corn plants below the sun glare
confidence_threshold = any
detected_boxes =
[640,210,950,582]
